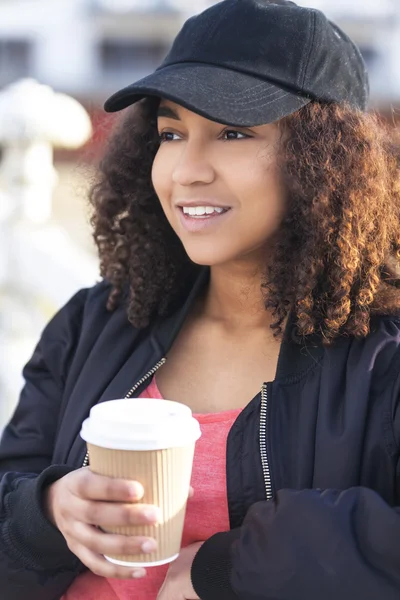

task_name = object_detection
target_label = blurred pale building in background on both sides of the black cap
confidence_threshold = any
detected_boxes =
[0,0,400,114]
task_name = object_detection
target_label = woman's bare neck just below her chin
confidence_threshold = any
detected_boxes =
[203,254,272,328]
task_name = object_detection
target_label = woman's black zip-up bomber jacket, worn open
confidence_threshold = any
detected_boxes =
[0,276,400,600]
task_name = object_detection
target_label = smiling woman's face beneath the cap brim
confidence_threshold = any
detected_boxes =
[152,100,285,266]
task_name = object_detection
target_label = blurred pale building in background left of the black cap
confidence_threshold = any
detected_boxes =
[0,0,212,104]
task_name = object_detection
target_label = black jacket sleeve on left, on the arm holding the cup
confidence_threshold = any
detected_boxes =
[0,290,87,600]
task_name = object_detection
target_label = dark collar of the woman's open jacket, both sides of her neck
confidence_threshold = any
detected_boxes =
[151,267,324,382]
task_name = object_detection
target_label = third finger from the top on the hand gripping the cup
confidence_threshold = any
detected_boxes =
[74,523,157,556]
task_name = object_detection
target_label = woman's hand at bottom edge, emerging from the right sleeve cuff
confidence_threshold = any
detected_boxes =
[157,542,204,600]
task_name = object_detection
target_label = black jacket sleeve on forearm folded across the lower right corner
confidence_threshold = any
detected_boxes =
[192,487,400,600]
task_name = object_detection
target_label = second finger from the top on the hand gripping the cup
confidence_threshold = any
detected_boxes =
[79,500,161,529]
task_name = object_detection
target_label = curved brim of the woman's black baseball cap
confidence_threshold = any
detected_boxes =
[104,63,311,127]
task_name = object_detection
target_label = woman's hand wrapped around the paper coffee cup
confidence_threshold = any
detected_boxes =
[44,467,170,579]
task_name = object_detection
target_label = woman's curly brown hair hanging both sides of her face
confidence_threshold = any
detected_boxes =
[90,98,400,343]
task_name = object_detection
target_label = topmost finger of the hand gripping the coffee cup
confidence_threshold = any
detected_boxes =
[71,467,144,502]
